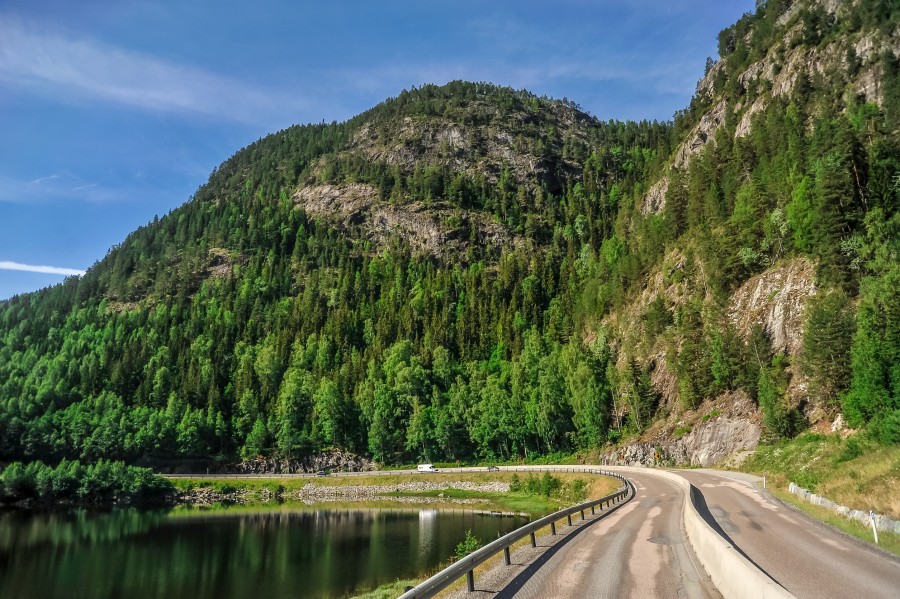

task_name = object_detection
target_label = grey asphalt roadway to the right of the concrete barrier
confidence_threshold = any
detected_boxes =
[674,470,900,599]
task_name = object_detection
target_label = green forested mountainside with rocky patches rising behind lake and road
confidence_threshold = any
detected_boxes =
[0,0,900,462]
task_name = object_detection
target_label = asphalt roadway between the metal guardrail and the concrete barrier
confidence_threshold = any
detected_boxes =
[488,473,720,599]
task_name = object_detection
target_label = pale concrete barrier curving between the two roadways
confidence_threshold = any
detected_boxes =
[606,466,794,599]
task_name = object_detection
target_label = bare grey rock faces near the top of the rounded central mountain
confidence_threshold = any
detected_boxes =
[292,96,602,260]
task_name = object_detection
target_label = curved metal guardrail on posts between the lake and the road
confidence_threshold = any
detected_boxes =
[399,468,633,599]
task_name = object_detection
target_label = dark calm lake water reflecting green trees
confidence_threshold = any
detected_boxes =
[0,509,527,599]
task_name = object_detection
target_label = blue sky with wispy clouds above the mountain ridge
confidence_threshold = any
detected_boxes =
[0,0,754,299]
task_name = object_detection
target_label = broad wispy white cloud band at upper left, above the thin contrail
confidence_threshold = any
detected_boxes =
[0,14,304,124]
